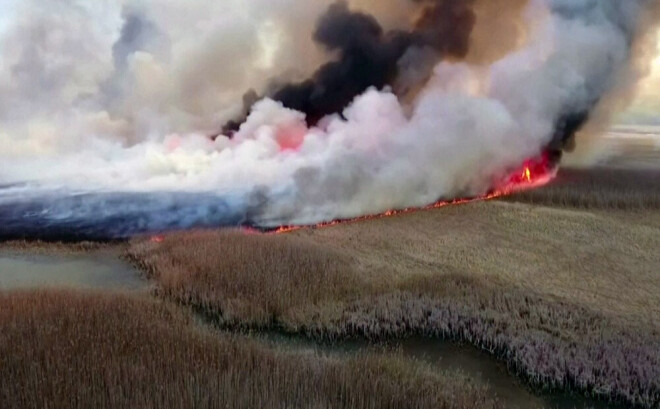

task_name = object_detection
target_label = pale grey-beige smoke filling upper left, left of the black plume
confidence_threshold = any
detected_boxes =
[0,0,338,151]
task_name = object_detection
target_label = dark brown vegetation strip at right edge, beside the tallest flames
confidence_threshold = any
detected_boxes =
[504,168,660,210]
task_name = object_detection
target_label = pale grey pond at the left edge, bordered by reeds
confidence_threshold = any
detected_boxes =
[0,251,147,290]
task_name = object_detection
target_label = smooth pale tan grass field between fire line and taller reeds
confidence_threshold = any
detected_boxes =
[293,195,660,325]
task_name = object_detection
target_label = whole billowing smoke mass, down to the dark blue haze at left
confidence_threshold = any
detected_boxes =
[0,0,655,238]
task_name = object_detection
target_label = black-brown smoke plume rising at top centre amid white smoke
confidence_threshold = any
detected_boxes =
[223,0,476,133]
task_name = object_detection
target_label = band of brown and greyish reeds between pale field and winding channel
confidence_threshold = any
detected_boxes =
[129,232,660,407]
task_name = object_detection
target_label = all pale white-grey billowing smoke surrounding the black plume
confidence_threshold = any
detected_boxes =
[0,0,647,236]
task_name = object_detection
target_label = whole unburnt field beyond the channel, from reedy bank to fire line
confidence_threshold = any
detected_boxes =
[127,170,660,407]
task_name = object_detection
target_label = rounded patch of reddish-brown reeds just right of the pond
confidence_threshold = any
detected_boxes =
[127,231,366,327]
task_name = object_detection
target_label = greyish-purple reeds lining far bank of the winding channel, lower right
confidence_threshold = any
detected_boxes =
[300,276,660,408]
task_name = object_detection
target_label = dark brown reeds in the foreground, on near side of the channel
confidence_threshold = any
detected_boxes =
[0,292,498,409]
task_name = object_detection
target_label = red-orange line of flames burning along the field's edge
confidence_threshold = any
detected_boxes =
[273,154,557,234]
